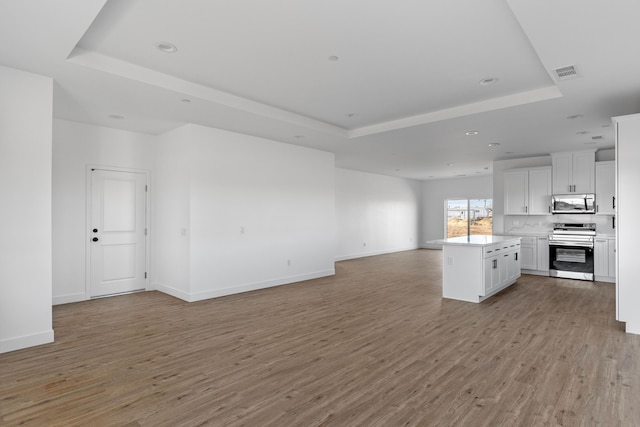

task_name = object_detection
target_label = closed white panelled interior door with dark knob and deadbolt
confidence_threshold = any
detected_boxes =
[89,169,146,297]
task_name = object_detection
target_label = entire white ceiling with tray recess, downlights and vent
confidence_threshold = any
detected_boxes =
[0,0,640,179]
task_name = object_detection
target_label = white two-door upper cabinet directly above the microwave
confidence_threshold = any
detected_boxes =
[551,150,596,194]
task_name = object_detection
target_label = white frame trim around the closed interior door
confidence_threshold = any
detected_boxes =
[84,164,151,300]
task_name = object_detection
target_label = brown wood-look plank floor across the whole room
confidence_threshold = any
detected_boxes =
[0,250,640,427]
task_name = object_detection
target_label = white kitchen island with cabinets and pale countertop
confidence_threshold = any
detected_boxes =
[442,236,521,302]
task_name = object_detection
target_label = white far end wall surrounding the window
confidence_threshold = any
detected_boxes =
[420,175,492,248]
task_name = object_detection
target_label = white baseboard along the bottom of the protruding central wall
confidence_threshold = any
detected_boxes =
[155,268,336,302]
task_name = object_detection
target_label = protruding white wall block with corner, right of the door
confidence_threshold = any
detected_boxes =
[154,125,335,301]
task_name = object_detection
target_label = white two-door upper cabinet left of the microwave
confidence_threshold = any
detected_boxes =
[504,166,551,215]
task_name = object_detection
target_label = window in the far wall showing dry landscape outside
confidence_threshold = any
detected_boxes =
[446,199,493,237]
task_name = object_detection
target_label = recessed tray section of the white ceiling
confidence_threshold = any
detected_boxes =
[68,0,562,138]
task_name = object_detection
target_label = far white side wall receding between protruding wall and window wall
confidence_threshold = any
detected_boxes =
[335,169,420,260]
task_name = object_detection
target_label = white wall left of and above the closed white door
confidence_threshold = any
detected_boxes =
[51,119,154,304]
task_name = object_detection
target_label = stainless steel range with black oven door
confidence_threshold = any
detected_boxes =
[549,222,596,280]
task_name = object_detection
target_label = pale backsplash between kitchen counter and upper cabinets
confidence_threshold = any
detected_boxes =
[504,214,616,235]
